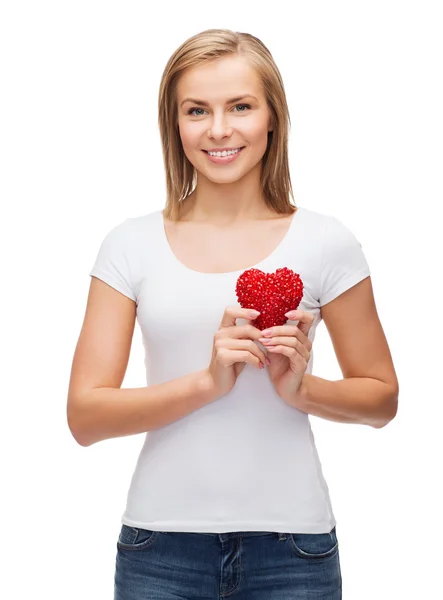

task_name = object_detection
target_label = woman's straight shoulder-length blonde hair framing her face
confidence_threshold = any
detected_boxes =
[158,29,296,220]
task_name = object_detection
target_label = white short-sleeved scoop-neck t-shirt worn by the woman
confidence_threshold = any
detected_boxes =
[90,207,370,533]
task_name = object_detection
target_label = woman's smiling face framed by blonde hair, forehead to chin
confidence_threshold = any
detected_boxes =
[177,56,272,183]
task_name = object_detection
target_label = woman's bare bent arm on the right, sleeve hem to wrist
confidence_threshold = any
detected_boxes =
[295,277,399,428]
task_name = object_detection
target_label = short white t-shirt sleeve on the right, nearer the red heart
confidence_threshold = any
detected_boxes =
[319,216,371,306]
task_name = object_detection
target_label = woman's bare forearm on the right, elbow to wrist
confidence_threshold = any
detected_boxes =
[296,374,397,428]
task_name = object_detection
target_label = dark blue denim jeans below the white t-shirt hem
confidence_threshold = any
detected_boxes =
[114,524,342,600]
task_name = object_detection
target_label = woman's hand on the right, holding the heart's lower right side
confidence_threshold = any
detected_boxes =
[258,310,314,406]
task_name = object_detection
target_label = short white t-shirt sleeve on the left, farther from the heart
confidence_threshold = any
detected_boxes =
[89,219,136,302]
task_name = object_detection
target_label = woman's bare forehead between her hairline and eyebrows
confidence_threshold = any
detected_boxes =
[177,56,263,102]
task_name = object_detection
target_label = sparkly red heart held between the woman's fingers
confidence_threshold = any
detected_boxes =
[235,267,303,331]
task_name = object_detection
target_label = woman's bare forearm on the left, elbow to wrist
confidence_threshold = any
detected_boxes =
[70,371,219,446]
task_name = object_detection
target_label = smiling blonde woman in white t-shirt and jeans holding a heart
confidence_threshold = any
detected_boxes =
[68,24,397,600]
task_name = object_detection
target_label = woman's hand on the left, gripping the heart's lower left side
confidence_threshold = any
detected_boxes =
[207,306,269,398]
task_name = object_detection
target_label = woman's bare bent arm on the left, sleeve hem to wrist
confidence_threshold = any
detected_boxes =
[67,277,215,446]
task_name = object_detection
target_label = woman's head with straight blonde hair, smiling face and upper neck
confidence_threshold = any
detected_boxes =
[158,29,295,222]
